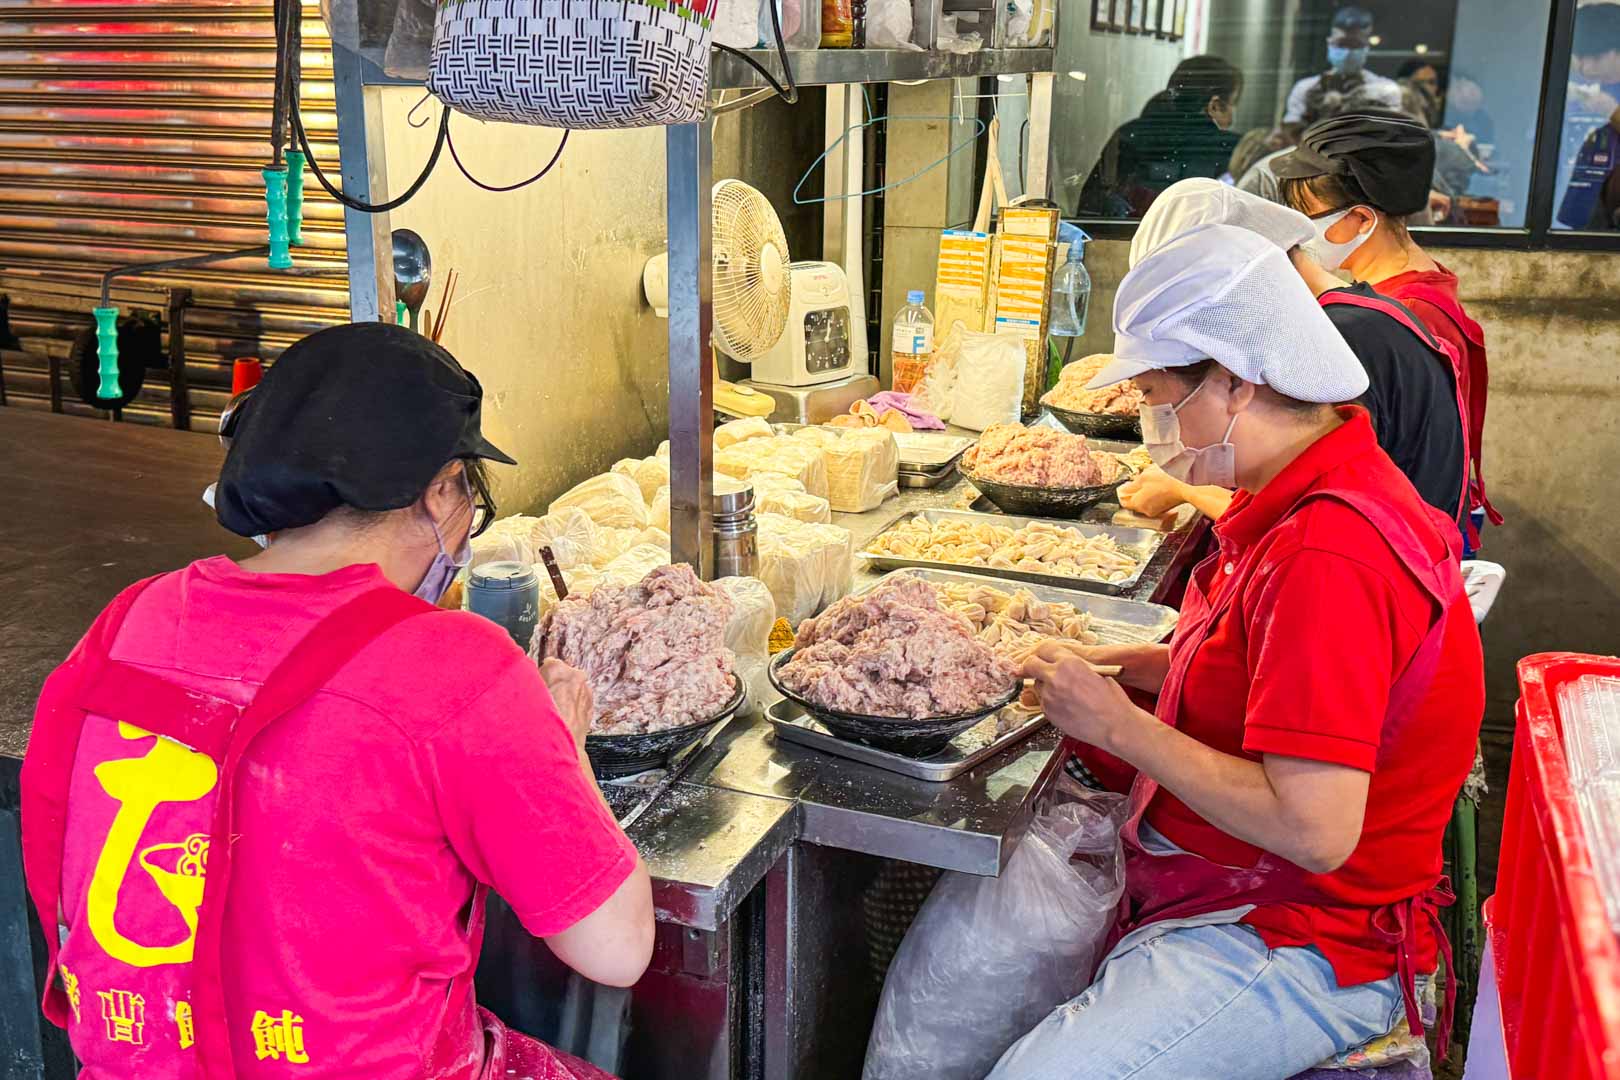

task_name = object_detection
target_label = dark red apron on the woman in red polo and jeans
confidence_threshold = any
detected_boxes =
[1118,489,1463,1048]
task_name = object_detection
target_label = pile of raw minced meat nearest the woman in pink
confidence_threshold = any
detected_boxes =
[536,563,734,735]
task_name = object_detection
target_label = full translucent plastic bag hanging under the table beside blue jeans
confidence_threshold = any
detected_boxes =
[862,779,1124,1080]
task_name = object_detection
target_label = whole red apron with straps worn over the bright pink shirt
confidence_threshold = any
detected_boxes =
[23,578,606,1080]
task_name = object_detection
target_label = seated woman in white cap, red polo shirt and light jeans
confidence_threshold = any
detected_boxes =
[991,225,1484,1080]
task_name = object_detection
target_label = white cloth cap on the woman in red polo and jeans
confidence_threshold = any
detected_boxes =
[1085,225,1367,403]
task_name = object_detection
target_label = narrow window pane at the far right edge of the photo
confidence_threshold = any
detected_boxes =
[1552,2,1620,232]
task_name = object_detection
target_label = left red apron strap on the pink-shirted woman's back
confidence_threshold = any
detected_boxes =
[21,578,157,1028]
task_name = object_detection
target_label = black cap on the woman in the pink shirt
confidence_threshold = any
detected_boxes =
[215,322,517,536]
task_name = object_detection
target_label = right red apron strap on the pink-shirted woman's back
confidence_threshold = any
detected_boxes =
[191,588,434,1080]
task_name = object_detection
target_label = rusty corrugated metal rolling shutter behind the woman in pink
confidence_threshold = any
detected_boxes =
[0,0,348,429]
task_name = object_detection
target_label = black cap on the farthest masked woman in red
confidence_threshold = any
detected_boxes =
[1272,112,1434,217]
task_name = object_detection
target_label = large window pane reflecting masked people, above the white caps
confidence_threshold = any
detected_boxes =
[1053,0,1555,228]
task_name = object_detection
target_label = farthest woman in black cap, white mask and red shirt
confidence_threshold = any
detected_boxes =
[1272,112,1502,547]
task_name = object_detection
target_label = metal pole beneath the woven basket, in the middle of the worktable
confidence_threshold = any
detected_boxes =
[664,120,714,581]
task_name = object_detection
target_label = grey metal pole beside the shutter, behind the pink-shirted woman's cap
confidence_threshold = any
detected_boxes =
[332,44,394,322]
